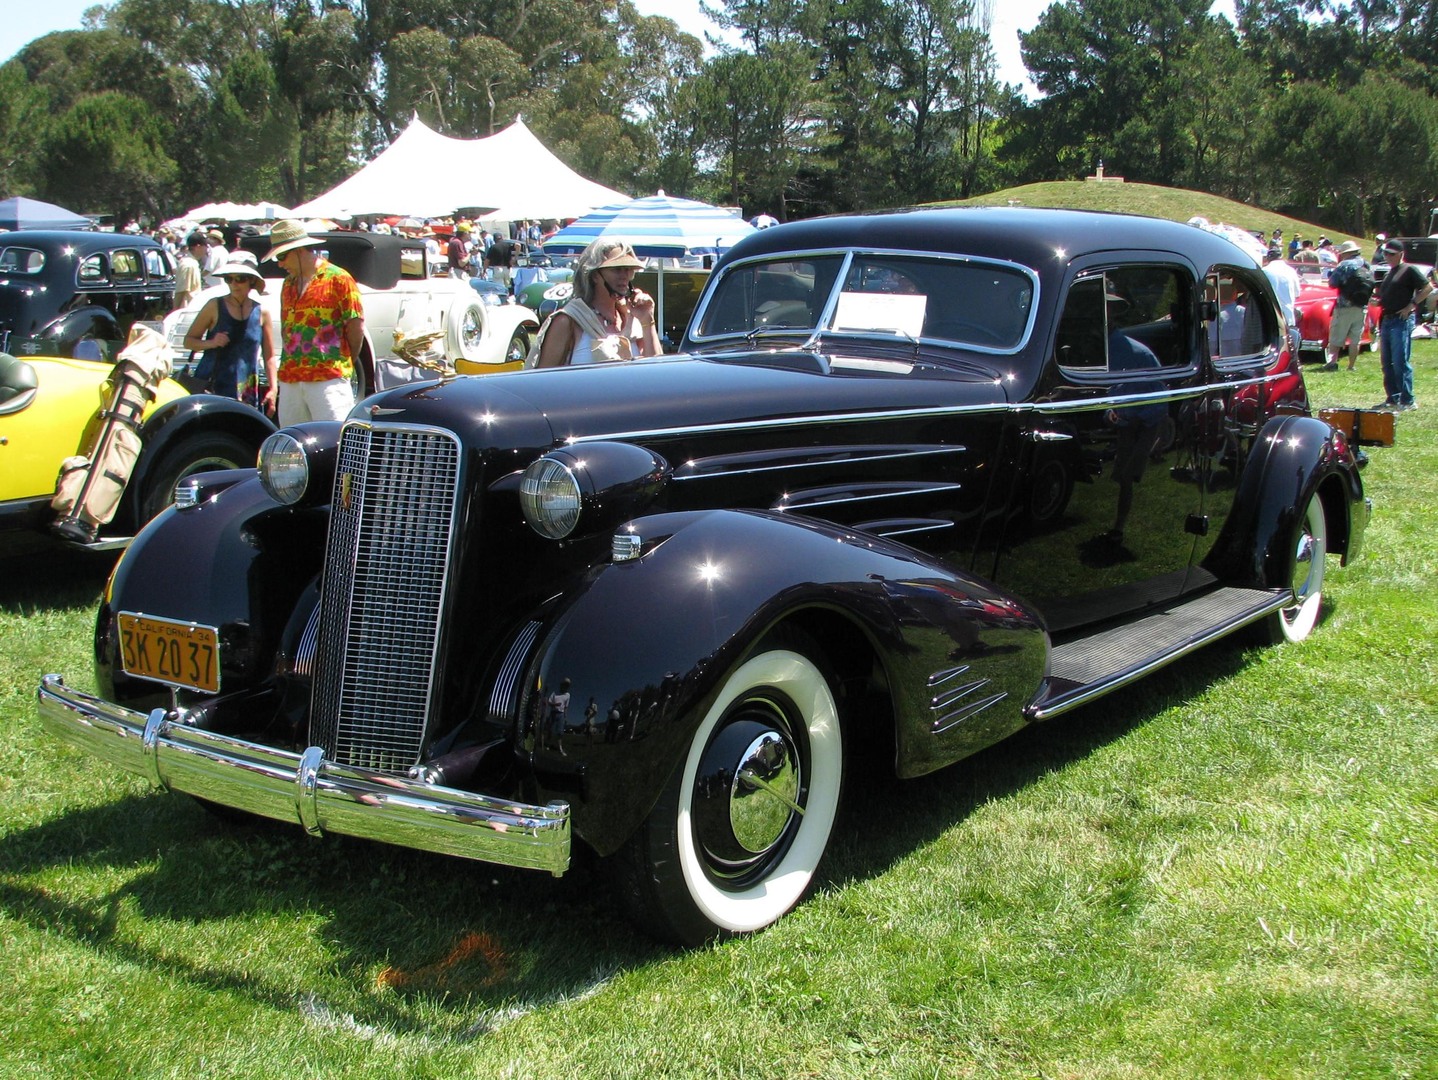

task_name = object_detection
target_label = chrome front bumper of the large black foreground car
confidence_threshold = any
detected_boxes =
[39,674,569,876]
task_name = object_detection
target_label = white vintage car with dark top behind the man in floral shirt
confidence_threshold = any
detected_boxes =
[164,233,539,395]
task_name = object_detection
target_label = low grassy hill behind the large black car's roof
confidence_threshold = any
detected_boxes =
[945,180,1372,256]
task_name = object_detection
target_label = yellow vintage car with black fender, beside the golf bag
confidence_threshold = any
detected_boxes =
[0,352,275,557]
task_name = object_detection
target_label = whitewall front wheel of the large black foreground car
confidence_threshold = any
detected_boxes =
[624,649,844,945]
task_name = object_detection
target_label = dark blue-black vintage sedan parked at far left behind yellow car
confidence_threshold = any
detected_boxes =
[0,230,175,361]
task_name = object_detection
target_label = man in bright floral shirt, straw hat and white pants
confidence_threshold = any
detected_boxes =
[265,221,364,427]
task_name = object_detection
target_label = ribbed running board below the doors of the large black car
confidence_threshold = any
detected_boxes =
[1024,588,1293,720]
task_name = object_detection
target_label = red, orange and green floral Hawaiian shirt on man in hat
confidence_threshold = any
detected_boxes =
[279,259,364,383]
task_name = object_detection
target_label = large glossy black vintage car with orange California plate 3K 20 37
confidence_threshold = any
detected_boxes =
[39,209,1369,942]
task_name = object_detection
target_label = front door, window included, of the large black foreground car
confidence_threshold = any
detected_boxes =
[995,257,1206,634]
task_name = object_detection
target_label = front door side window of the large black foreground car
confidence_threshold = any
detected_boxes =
[1054,266,1191,371]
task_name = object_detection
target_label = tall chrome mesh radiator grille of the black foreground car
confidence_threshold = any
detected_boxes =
[309,423,460,772]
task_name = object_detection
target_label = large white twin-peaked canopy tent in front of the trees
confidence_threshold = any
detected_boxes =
[295,116,627,221]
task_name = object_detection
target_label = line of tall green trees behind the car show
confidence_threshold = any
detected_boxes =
[0,0,1438,233]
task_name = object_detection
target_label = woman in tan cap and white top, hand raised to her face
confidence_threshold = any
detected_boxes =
[535,240,661,368]
